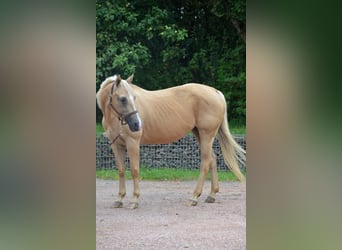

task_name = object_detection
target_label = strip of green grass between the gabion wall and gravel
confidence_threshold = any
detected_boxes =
[96,167,246,181]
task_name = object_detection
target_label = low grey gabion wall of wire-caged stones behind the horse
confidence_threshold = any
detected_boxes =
[96,134,246,170]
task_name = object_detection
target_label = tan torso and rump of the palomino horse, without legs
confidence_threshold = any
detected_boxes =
[134,83,226,144]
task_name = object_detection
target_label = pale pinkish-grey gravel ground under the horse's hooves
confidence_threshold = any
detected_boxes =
[96,179,246,250]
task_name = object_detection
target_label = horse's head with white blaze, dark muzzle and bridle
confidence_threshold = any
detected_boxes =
[109,75,141,132]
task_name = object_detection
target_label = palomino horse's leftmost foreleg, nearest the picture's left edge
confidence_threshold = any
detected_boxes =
[112,144,126,208]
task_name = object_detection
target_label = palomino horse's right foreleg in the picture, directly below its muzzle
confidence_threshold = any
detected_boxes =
[127,142,140,209]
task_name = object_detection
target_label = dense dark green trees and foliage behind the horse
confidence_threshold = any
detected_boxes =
[96,0,246,122]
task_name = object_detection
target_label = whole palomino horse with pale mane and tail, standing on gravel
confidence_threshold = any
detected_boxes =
[96,75,246,208]
